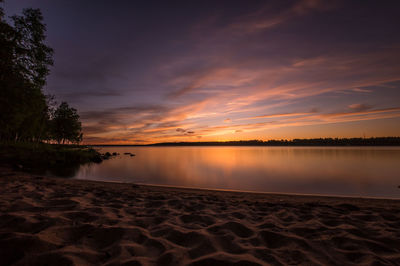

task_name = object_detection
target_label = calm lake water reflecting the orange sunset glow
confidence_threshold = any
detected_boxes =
[74,147,400,198]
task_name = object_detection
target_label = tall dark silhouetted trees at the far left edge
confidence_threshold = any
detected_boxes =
[0,1,53,141]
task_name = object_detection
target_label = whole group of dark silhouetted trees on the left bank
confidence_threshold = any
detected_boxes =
[0,0,82,144]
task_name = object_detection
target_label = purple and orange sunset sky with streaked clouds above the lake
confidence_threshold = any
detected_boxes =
[2,0,400,144]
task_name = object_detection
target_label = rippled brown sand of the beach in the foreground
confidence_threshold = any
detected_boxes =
[0,169,400,266]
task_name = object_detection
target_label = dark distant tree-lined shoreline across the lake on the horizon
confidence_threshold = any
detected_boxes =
[87,137,400,147]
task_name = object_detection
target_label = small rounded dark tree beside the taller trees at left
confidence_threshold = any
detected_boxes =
[51,102,82,144]
